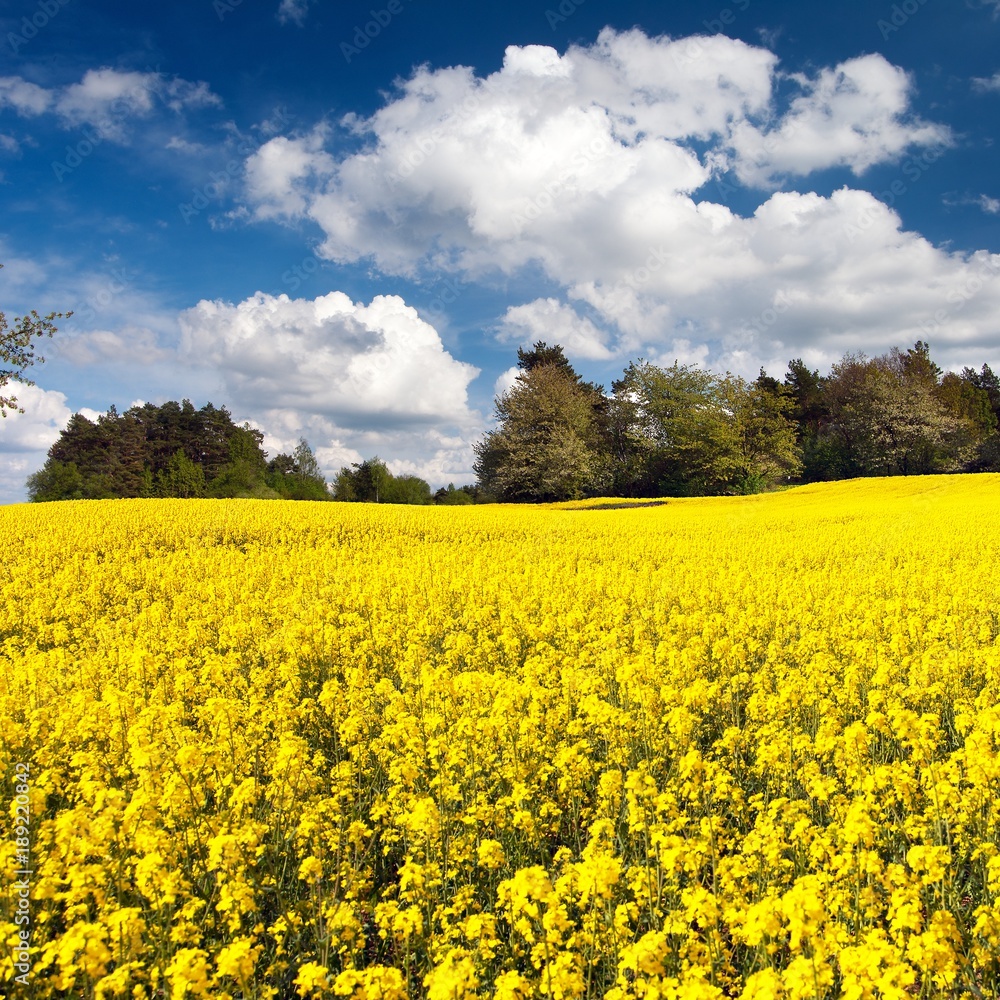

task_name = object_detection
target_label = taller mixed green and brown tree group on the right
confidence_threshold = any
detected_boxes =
[474,341,1000,502]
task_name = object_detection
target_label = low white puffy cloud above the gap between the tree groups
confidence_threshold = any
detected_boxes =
[180,292,482,484]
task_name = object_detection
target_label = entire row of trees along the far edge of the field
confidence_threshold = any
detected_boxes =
[19,341,1000,505]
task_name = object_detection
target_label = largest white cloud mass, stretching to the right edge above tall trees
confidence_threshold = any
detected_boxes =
[242,29,1000,372]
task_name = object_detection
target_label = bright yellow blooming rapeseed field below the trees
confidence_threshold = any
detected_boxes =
[0,475,1000,1000]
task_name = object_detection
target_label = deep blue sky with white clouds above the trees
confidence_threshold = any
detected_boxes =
[0,0,1000,502]
